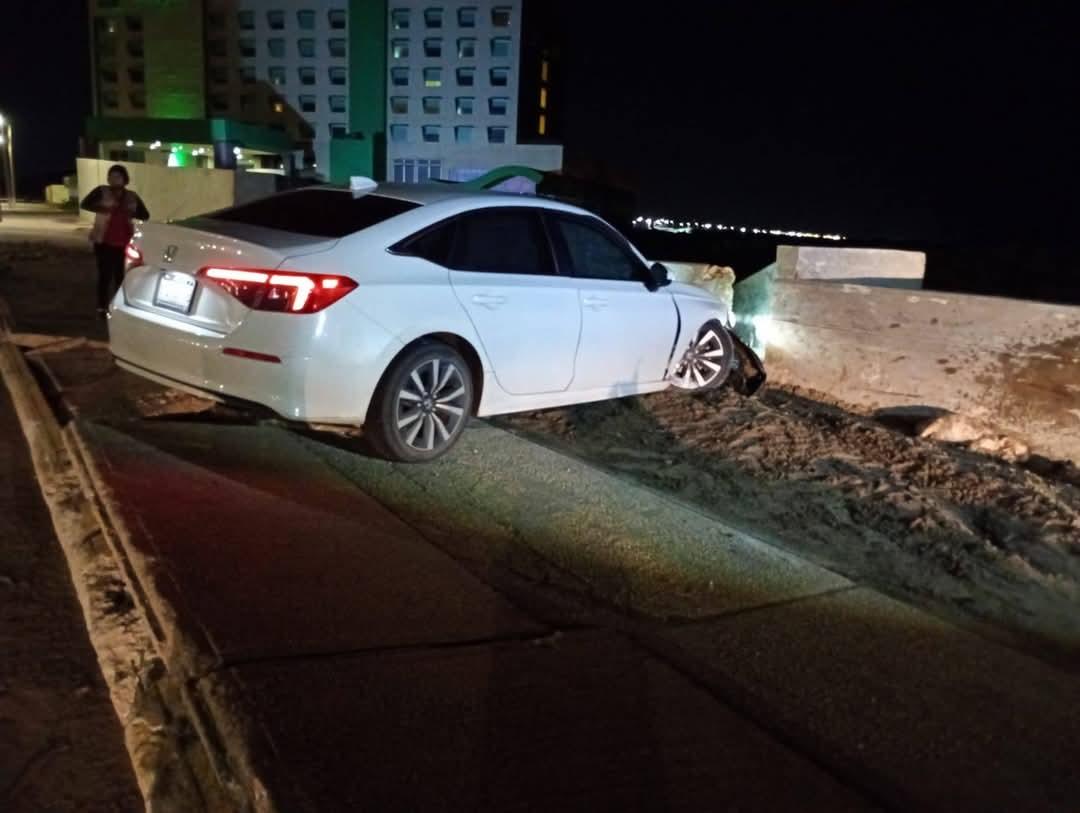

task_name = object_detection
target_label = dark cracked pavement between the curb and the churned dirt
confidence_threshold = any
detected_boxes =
[0,237,1080,810]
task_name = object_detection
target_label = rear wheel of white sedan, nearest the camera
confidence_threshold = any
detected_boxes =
[364,342,473,463]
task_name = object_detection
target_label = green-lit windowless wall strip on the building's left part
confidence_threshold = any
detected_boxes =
[137,0,206,119]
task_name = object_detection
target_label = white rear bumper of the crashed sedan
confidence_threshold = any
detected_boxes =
[109,293,395,424]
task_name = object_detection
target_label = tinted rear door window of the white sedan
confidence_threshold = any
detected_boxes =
[448,207,554,274]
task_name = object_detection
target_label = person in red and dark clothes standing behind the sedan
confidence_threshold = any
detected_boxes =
[81,164,150,317]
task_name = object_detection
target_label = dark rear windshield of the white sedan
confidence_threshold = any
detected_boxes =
[208,189,419,238]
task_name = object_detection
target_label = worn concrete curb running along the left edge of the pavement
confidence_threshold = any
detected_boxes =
[0,319,250,813]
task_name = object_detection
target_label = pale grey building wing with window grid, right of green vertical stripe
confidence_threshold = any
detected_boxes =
[387,0,563,181]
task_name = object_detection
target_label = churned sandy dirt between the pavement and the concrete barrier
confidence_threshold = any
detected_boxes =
[498,388,1080,654]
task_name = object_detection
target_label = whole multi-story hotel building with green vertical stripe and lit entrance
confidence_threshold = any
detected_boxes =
[87,0,562,181]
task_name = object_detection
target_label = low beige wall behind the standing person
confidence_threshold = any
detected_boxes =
[78,158,275,220]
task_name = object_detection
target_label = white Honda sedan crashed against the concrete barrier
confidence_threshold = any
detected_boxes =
[109,185,764,461]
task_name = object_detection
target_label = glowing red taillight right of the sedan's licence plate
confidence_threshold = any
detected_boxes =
[199,267,356,313]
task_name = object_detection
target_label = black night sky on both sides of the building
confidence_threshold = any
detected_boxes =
[0,0,1080,243]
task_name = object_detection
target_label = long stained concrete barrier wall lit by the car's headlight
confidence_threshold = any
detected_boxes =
[760,279,1080,462]
